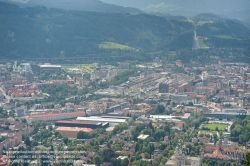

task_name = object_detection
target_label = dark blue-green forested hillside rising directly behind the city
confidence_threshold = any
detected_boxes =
[0,2,250,59]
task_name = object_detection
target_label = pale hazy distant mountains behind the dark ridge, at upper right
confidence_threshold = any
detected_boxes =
[101,0,250,23]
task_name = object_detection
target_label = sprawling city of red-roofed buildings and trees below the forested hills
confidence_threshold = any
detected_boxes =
[0,56,250,166]
